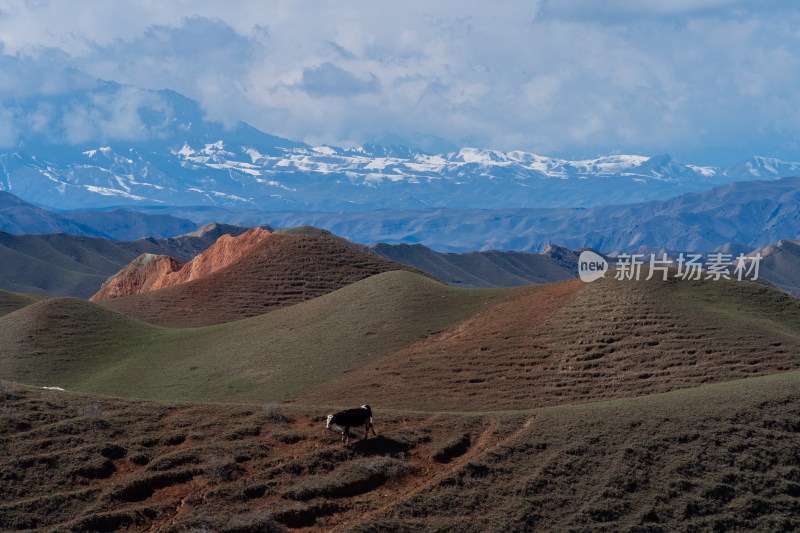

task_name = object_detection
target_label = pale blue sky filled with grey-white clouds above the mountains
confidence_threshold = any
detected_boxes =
[0,0,800,164]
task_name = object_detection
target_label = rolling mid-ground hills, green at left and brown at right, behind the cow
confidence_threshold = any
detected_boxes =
[6,271,800,411]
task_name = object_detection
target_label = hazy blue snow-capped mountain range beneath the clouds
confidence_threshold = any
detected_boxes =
[0,83,800,211]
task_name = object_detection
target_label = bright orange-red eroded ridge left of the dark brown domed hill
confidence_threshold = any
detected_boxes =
[90,228,272,301]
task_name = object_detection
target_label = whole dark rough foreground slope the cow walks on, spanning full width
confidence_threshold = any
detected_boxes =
[0,372,800,533]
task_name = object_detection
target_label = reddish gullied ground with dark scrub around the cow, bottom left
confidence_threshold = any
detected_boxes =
[0,382,514,532]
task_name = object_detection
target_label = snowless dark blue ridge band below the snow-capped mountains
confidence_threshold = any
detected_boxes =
[0,172,800,253]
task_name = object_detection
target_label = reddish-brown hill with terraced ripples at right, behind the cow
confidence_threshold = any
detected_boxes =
[295,272,800,411]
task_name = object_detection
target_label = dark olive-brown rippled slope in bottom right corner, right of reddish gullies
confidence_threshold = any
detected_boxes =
[348,372,800,532]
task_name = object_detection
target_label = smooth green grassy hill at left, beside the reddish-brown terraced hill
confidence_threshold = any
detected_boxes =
[0,271,505,403]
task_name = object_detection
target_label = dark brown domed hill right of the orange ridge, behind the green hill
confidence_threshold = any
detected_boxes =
[98,234,428,327]
